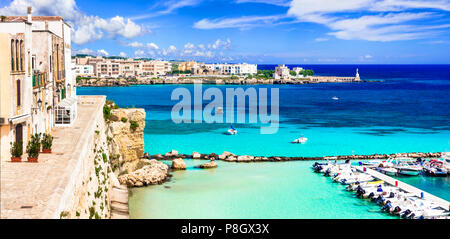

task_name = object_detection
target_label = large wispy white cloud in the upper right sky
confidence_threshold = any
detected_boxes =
[288,0,450,42]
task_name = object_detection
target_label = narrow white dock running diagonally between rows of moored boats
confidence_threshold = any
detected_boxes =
[352,166,450,210]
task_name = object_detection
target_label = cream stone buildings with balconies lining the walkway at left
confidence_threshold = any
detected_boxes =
[0,7,76,159]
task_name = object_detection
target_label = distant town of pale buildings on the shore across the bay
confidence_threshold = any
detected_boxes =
[71,55,360,86]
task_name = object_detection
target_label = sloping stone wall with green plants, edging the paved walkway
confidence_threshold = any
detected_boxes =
[53,98,118,219]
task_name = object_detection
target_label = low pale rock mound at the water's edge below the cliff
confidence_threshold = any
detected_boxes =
[119,159,169,187]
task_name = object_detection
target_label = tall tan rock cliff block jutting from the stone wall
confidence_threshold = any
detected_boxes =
[107,108,145,172]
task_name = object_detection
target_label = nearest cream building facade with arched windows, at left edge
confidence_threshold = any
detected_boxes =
[0,12,32,161]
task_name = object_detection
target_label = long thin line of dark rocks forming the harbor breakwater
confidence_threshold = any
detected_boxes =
[144,150,441,163]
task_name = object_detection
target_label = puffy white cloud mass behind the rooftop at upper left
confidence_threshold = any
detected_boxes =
[0,0,149,45]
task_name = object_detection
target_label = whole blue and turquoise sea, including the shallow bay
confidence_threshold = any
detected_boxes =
[77,65,450,218]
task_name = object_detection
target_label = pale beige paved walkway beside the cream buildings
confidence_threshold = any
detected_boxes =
[0,96,104,218]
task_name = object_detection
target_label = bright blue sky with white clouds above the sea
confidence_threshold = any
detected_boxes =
[0,0,450,64]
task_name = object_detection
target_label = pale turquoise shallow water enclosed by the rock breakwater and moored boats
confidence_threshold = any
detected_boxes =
[129,160,394,219]
